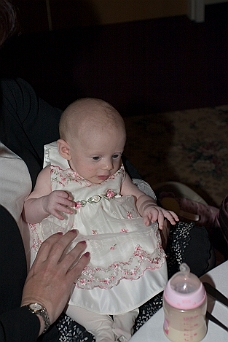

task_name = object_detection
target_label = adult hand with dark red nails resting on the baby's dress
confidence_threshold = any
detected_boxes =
[21,230,90,334]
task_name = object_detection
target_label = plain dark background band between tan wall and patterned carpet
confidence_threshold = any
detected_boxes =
[0,3,228,116]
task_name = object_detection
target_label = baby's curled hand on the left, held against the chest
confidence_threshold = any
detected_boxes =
[42,190,75,220]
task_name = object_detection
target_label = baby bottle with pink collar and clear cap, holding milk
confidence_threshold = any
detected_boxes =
[163,263,207,342]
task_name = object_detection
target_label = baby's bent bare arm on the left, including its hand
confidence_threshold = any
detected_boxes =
[23,166,75,223]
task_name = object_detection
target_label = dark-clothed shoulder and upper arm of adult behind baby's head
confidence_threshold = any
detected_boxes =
[0,78,61,185]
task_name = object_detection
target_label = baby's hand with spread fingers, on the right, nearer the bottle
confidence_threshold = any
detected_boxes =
[142,205,179,229]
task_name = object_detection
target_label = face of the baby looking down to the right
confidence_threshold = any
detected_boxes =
[69,128,125,184]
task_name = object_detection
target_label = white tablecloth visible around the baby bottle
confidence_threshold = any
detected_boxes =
[130,261,228,342]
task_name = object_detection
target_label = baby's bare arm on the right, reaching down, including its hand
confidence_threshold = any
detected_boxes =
[121,173,179,229]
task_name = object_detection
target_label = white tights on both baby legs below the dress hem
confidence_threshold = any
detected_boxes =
[66,305,139,342]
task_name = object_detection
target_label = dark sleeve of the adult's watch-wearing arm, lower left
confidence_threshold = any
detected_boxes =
[0,205,58,342]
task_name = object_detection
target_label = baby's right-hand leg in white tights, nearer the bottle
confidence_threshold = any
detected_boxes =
[113,309,139,342]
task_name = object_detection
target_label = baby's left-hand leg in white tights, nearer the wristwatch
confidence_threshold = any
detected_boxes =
[66,305,115,342]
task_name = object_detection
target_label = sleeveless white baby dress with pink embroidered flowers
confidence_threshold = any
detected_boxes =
[30,143,167,315]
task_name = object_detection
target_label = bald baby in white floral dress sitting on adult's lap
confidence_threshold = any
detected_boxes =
[24,98,178,342]
